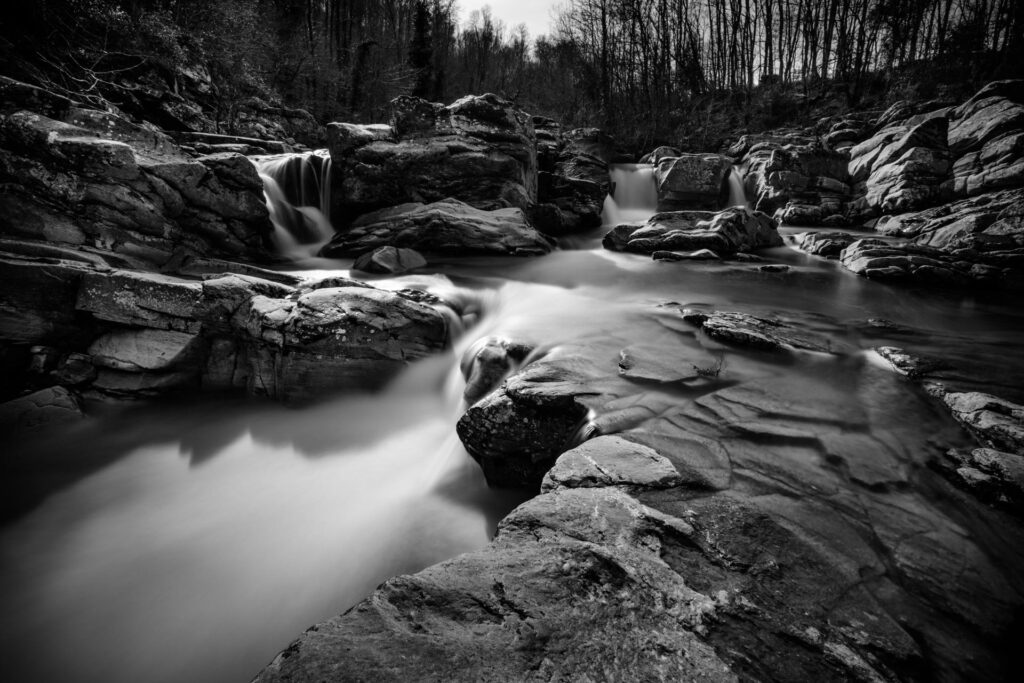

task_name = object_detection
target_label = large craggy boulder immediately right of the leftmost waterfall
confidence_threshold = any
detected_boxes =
[328,94,537,217]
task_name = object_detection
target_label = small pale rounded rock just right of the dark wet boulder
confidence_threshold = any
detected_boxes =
[541,436,682,493]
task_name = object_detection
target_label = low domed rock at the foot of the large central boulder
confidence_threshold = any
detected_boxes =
[321,199,552,257]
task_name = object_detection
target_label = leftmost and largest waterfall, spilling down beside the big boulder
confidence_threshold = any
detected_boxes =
[252,150,334,256]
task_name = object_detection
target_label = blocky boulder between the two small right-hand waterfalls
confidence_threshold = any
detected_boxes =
[654,155,732,211]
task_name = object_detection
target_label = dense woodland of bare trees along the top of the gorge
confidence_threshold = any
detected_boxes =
[0,0,1024,148]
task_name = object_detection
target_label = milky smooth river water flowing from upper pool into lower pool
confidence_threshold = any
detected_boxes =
[0,167,1024,682]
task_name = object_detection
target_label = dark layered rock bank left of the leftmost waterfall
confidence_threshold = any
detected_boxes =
[0,79,270,264]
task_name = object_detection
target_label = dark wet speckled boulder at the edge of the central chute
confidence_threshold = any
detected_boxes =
[456,360,589,488]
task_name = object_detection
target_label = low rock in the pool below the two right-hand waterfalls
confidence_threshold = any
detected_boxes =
[603,207,782,256]
